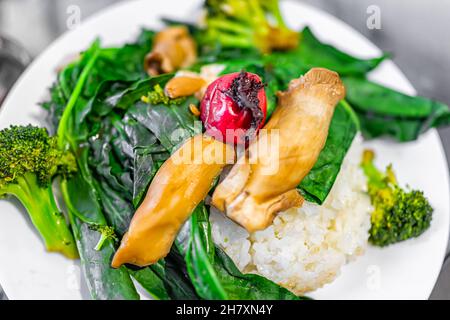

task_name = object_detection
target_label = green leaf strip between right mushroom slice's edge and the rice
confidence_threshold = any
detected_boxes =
[298,101,359,204]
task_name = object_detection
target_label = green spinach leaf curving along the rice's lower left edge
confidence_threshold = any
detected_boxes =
[177,203,303,300]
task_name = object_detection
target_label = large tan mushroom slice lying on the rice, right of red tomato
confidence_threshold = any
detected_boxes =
[212,68,345,232]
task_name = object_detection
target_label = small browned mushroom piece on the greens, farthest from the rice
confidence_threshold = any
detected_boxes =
[144,26,197,76]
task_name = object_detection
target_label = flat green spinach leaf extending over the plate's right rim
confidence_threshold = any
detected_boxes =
[344,77,450,142]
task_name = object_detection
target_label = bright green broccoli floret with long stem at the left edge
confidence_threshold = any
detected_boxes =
[0,125,78,258]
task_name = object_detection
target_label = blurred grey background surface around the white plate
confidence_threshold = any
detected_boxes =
[0,0,450,299]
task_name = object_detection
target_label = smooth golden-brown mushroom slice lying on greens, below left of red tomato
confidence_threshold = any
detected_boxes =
[112,135,235,268]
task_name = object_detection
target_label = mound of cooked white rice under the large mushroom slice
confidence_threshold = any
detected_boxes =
[211,137,370,294]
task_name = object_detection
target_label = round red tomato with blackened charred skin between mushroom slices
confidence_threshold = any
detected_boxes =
[200,71,267,144]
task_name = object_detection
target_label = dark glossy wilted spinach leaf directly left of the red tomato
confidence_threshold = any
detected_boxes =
[89,84,202,211]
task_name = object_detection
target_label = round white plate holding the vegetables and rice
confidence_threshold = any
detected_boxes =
[0,0,449,299]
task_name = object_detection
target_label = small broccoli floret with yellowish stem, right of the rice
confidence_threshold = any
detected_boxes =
[361,150,433,247]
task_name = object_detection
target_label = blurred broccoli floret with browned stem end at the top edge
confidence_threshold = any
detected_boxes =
[204,0,299,53]
